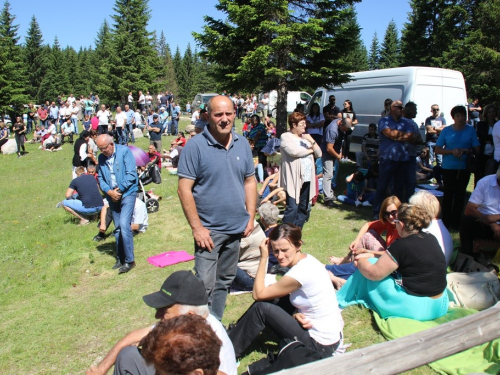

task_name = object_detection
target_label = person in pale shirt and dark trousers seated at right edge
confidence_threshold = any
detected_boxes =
[460,168,500,255]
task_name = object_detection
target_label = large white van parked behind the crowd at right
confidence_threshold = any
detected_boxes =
[307,66,467,152]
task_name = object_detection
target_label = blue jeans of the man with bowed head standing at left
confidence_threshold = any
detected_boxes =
[108,194,135,263]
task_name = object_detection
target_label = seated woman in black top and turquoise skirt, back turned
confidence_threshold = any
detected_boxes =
[337,204,448,321]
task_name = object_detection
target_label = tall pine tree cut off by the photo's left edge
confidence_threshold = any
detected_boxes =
[0,1,29,116]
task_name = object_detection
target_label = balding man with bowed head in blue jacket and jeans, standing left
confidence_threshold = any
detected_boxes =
[96,134,139,273]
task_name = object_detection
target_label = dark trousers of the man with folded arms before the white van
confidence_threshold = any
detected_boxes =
[373,158,411,215]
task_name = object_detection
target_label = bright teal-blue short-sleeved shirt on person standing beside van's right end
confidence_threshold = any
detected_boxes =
[436,125,479,169]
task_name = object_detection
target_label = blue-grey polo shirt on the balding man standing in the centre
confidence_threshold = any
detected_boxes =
[177,125,255,234]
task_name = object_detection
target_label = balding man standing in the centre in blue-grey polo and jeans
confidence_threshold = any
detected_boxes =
[177,96,257,320]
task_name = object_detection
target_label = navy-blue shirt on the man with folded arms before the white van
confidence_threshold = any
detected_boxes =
[378,116,412,161]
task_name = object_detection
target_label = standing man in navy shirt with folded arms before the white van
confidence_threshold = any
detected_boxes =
[373,100,415,218]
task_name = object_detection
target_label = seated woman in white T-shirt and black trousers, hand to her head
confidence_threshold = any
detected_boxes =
[229,224,342,358]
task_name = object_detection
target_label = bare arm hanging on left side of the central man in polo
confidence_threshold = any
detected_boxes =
[177,176,213,251]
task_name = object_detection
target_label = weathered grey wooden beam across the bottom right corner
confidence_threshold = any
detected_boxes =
[280,302,500,375]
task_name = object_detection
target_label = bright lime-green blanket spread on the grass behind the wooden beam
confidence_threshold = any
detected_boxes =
[373,308,500,375]
